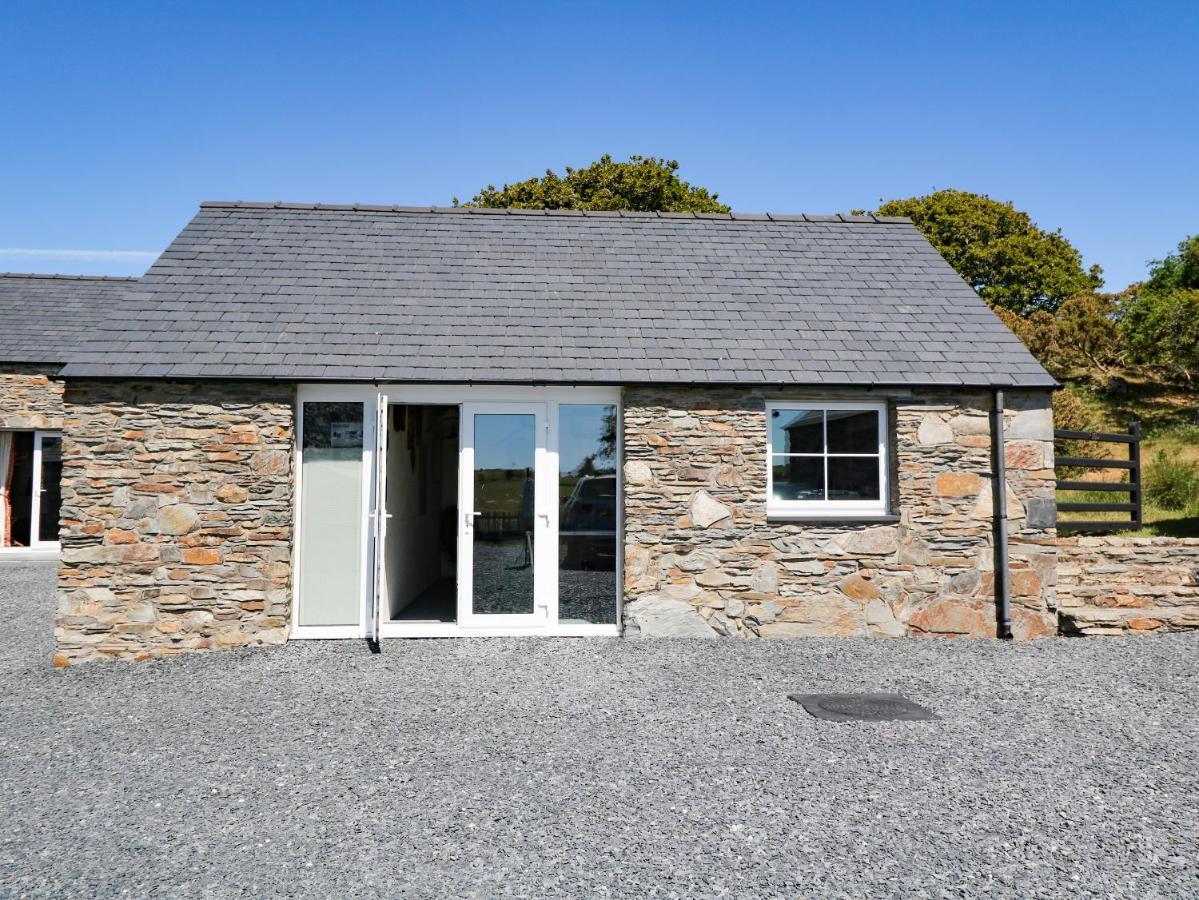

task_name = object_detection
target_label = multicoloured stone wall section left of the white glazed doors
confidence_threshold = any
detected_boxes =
[54,381,294,666]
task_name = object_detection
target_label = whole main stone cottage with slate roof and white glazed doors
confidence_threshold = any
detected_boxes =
[0,203,1056,665]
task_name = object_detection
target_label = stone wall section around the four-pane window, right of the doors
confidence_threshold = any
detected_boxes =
[623,388,1056,638]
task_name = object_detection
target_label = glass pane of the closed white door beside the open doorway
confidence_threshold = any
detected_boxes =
[469,412,538,616]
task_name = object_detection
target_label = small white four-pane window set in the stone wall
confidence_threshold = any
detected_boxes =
[766,403,887,518]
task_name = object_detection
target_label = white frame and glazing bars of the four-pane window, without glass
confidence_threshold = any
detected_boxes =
[766,400,891,519]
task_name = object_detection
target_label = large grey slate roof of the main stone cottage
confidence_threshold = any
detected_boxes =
[66,203,1054,386]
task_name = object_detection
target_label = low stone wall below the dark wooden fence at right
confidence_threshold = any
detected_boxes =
[1058,536,1199,634]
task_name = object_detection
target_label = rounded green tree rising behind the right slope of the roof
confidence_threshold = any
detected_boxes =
[875,191,1103,315]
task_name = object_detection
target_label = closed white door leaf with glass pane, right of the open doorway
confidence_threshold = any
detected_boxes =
[458,403,556,632]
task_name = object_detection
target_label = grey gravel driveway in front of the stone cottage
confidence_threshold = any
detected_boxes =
[0,563,1199,896]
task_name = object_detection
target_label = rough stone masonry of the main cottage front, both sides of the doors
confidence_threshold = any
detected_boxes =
[46,380,1056,665]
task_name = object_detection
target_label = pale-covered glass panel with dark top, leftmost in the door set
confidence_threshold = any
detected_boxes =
[297,401,364,626]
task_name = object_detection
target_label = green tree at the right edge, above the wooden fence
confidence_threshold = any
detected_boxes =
[1120,235,1199,385]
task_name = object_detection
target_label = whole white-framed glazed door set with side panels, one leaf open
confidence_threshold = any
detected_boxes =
[291,385,621,638]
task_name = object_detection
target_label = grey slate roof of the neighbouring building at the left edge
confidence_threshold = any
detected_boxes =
[0,272,137,364]
